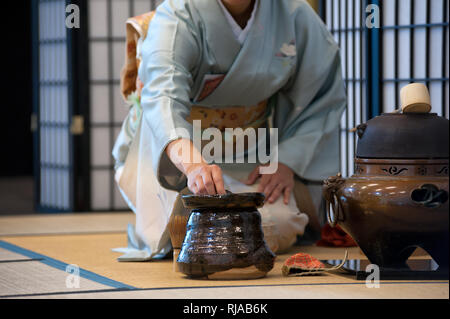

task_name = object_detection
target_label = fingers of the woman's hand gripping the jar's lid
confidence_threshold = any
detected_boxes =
[186,163,226,195]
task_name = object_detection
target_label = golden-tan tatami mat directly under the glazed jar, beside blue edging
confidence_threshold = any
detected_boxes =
[2,234,361,288]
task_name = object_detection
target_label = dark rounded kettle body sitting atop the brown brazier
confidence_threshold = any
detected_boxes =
[356,113,449,159]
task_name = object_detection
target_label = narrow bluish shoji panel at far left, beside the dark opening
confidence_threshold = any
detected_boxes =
[33,0,73,211]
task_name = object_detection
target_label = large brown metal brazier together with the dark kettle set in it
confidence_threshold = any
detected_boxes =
[323,113,449,269]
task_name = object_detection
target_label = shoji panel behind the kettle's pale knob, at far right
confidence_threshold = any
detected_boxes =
[381,0,449,118]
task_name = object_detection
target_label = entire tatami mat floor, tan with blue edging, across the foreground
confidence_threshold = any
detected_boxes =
[0,214,449,299]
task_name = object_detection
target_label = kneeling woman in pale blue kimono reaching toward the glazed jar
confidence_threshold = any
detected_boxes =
[113,0,346,260]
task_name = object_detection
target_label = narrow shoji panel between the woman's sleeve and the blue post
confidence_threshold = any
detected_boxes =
[321,0,367,176]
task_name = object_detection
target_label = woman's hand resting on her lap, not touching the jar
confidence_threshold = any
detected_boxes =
[246,163,294,205]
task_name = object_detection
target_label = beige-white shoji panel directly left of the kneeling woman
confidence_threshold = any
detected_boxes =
[88,0,161,210]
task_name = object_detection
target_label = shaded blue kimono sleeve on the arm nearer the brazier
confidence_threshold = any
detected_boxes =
[274,4,346,181]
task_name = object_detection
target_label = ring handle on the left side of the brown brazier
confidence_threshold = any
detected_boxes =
[322,173,345,227]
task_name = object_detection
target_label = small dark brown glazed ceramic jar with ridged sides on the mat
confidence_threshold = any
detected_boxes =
[177,193,275,279]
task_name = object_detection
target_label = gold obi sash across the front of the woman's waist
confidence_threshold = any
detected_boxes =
[186,100,270,132]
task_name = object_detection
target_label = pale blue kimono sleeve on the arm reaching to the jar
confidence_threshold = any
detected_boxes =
[139,0,200,190]
